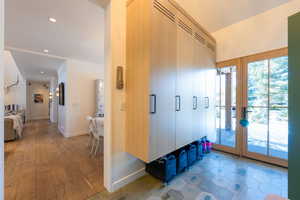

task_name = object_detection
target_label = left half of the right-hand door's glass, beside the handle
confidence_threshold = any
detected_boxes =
[247,60,269,155]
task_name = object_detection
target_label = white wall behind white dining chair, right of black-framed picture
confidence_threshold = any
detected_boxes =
[66,60,104,136]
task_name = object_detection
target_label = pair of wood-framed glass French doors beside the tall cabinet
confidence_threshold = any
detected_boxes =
[215,49,288,167]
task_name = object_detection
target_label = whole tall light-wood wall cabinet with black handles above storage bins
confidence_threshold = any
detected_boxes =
[125,0,215,162]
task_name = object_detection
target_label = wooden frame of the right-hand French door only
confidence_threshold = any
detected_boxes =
[240,48,288,167]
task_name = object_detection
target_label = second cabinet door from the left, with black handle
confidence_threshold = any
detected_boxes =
[176,20,194,148]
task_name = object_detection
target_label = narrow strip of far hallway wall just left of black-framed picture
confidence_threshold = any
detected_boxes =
[50,78,58,123]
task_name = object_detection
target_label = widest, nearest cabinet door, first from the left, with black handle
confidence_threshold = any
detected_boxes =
[150,2,176,160]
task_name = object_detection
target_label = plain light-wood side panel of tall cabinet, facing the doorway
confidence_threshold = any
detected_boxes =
[125,1,150,161]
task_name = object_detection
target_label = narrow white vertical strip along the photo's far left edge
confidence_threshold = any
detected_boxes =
[0,0,4,199]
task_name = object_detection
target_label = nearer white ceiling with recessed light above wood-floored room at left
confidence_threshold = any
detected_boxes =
[5,0,105,64]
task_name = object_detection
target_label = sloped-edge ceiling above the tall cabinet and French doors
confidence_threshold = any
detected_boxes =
[176,0,291,33]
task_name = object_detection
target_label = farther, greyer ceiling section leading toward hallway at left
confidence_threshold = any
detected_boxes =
[11,50,65,82]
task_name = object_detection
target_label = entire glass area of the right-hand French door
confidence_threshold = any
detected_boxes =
[245,56,288,164]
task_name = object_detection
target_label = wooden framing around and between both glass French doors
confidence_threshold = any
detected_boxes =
[214,47,288,167]
